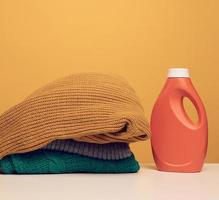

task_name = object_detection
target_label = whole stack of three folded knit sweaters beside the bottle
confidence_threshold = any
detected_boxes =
[0,73,150,174]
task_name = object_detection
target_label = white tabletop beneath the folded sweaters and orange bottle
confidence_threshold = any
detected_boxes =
[0,164,219,200]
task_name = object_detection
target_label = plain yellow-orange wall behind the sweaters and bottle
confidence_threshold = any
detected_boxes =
[0,0,219,162]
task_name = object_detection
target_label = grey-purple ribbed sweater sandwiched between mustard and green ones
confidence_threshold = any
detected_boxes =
[43,139,132,160]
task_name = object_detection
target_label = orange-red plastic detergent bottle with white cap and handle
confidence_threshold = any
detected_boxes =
[151,68,208,172]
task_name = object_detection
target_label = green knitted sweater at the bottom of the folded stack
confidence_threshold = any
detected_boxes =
[0,150,139,174]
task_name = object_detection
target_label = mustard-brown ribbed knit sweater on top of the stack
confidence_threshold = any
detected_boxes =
[0,73,150,158]
